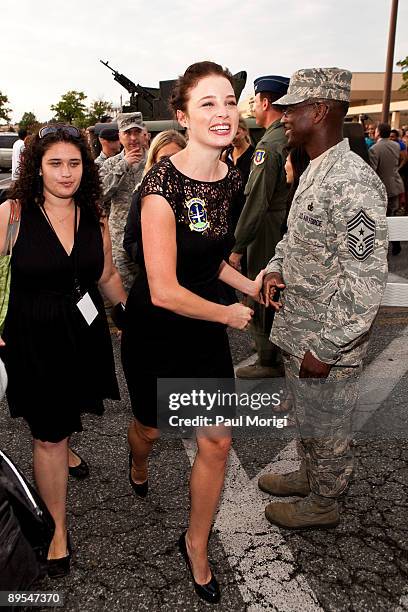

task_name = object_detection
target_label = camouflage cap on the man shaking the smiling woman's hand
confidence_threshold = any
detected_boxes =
[274,68,352,106]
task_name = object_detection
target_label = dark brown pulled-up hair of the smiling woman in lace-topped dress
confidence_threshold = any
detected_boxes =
[169,61,234,115]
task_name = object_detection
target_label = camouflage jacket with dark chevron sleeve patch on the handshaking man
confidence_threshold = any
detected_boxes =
[266,139,388,366]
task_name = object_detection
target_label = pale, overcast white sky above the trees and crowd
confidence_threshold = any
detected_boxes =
[0,0,408,121]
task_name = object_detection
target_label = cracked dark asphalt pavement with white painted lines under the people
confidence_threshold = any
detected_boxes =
[0,245,408,612]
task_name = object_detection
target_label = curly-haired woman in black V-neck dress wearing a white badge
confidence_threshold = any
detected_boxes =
[0,124,126,577]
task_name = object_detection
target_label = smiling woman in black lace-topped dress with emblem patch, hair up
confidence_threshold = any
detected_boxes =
[122,62,263,602]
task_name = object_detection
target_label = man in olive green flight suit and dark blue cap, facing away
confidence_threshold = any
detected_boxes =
[229,76,289,378]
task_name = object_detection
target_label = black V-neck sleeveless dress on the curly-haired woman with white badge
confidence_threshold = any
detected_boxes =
[2,206,119,442]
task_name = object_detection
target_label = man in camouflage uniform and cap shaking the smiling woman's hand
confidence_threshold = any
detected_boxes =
[259,68,388,528]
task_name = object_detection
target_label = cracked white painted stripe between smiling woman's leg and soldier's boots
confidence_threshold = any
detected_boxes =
[183,440,322,612]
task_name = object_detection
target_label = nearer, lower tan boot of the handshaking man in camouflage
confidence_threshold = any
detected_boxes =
[265,493,340,529]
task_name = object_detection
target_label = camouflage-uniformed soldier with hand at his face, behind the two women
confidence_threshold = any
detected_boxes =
[99,113,146,292]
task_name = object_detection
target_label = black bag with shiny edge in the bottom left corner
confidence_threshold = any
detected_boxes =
[0,450,55,590]
